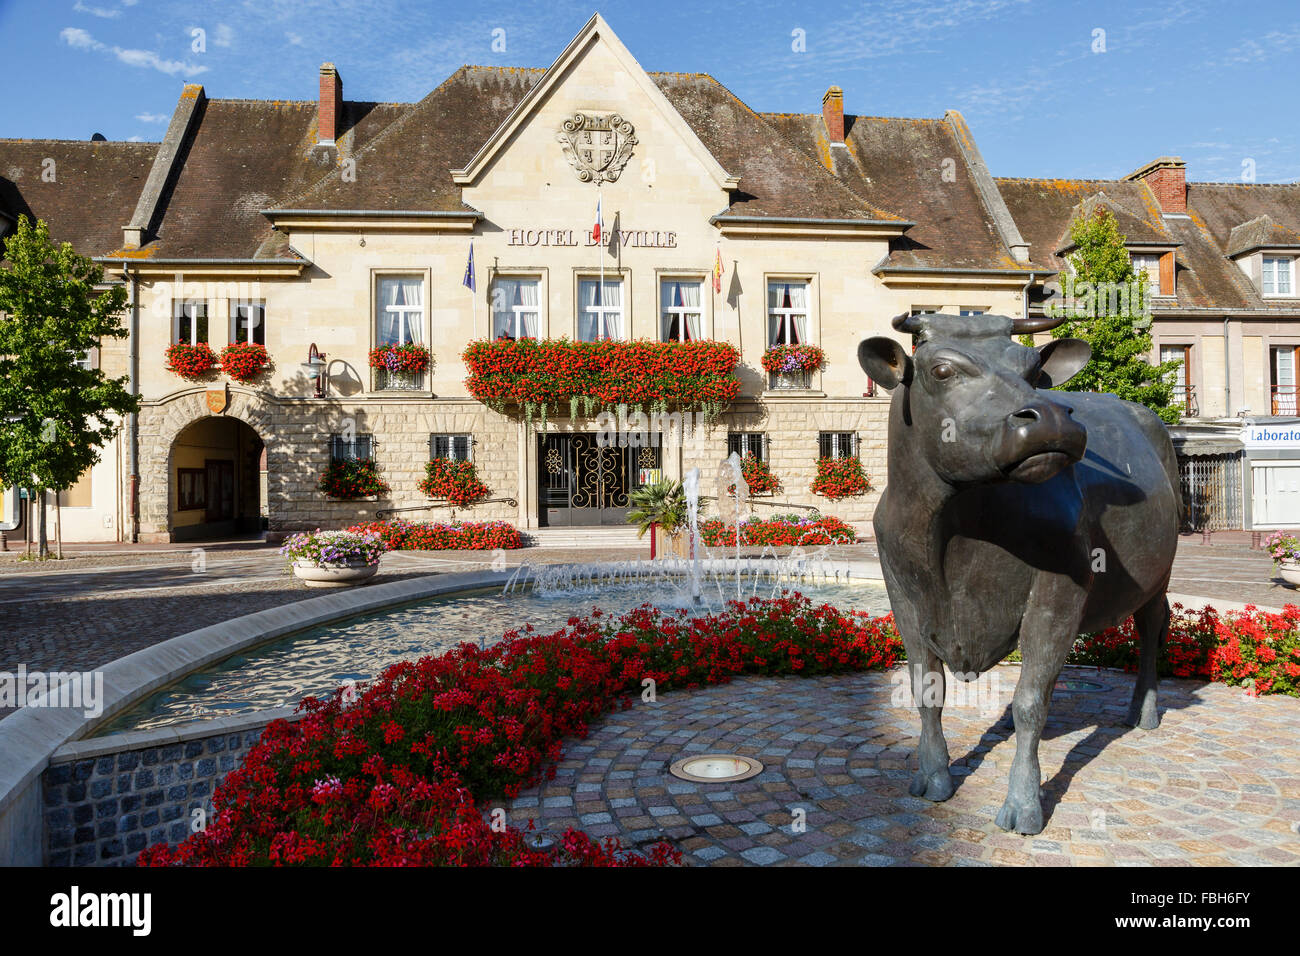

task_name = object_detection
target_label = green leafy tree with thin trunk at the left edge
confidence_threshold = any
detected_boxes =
[0,216,139,558]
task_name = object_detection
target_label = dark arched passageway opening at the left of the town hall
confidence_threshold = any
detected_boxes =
[168,415,268,541]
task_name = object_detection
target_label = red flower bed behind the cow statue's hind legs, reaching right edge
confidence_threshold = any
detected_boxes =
[1069,605,1300,697]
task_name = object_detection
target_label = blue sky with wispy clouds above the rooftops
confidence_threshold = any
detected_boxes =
[0,0,1300,182]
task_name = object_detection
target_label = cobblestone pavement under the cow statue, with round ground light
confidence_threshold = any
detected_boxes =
[507,665,1300,866]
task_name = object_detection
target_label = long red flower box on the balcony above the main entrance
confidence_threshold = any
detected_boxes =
[463,338,740,414]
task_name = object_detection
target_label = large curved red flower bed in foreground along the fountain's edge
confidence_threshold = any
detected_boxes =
[139,594,901,866]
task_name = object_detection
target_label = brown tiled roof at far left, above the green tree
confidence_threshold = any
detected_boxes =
[0,139,159,255]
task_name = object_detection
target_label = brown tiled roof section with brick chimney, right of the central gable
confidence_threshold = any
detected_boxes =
[763,113,1044,272]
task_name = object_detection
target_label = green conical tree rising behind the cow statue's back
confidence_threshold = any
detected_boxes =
[1052,208,1182,424]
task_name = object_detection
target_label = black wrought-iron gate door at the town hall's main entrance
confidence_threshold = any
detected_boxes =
[538,434,659,527]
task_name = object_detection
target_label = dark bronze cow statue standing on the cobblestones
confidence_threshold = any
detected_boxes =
[858,315,1182,834]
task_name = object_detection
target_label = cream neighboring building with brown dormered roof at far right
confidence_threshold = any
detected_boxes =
[997,156,1300,529]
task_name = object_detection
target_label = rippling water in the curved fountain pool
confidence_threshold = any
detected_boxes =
[99,580,889,735]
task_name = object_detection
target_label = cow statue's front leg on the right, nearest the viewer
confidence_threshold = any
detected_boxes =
[996,605,1079,835]
